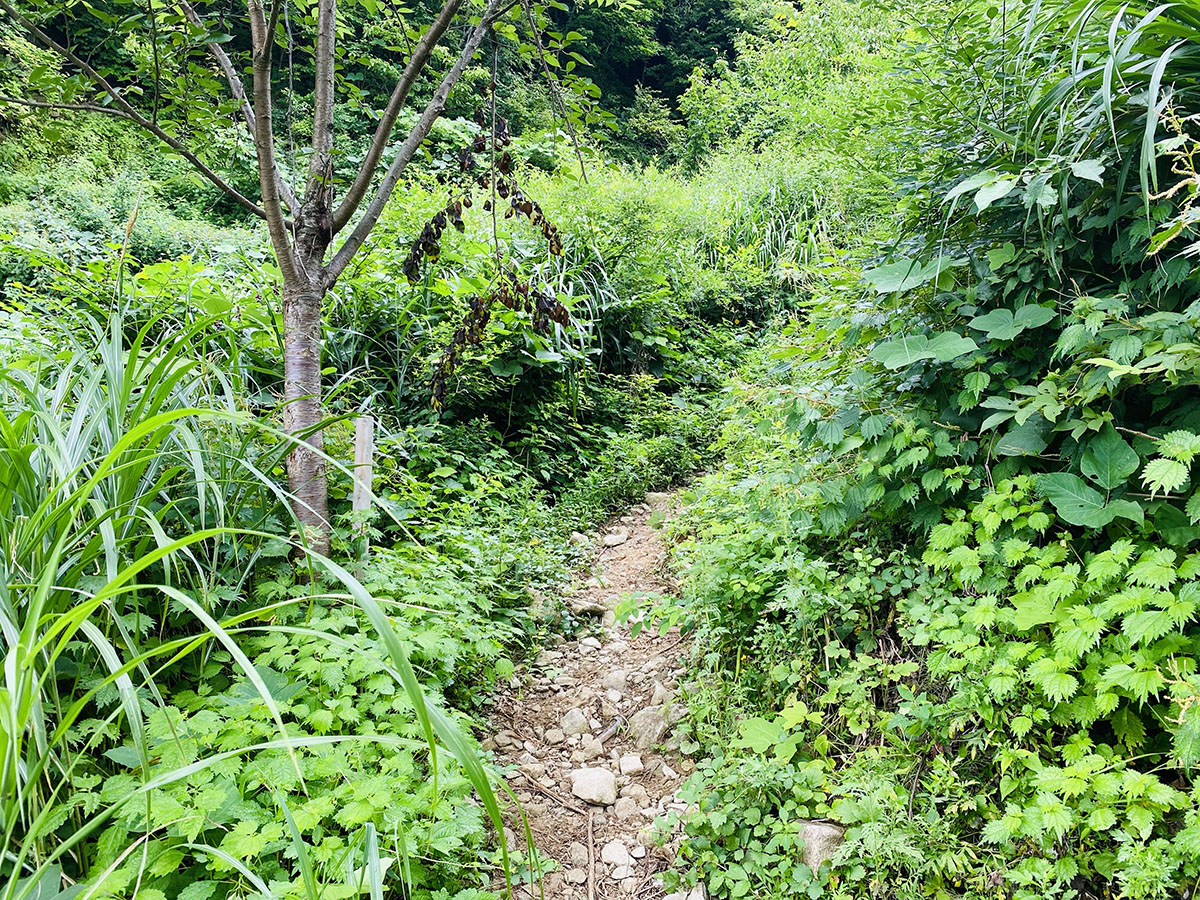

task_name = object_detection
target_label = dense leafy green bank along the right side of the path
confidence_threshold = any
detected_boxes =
[659,2,1200,898]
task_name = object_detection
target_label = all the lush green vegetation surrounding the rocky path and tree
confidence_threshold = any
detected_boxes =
[7,0,1200,900]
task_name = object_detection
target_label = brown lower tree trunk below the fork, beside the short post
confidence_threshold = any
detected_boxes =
[283,283,330,556]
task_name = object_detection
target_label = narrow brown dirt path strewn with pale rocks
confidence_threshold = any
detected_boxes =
[484,494,702,900]
